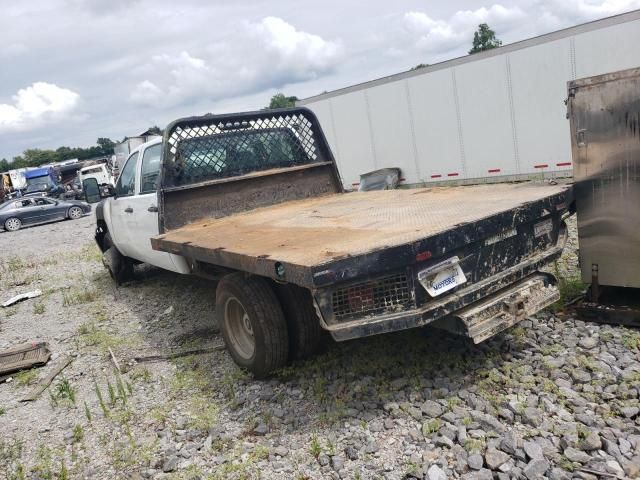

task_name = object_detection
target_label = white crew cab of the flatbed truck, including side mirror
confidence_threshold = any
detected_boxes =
[92,137,191,282]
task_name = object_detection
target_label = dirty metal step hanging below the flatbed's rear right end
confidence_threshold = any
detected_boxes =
[453,273,560,344]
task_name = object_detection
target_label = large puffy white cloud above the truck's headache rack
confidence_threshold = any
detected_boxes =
[130,17,342,106]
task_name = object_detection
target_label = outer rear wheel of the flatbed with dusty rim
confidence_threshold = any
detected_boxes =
[216,273,289,378]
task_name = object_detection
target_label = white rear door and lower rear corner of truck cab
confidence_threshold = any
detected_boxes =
[123,143,190,273]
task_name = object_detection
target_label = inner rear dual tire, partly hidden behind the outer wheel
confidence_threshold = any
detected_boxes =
[275,283,323,360]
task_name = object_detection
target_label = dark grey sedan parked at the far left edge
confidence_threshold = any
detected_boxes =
[0,197,91,232]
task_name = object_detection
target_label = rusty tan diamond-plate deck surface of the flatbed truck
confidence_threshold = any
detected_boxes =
[152,183,567,267]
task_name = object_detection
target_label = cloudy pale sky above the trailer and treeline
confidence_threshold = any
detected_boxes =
[0,0,640,159]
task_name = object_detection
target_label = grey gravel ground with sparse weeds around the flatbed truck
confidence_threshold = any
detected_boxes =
[0,217,640,480]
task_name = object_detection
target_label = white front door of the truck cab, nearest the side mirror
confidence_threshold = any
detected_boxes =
[109,152,140,260]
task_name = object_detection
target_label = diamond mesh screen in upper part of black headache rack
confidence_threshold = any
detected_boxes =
[164,113,322,187]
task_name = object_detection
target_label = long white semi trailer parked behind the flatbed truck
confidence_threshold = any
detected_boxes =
[298,10,640,188]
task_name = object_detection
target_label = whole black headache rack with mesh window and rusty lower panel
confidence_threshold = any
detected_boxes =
[158,108,342,232]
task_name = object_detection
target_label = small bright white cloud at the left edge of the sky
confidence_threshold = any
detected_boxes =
[0,82,80,131]
